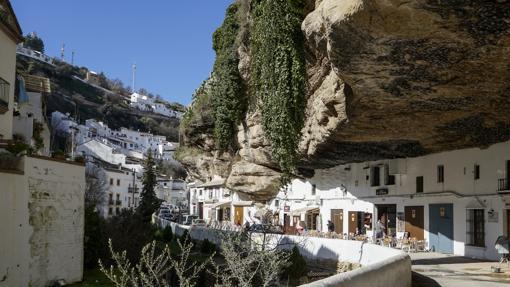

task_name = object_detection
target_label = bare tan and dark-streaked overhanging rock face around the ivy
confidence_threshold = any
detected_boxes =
[181,0,510,200]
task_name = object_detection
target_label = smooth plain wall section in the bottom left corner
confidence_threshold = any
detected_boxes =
[0,172,32,287]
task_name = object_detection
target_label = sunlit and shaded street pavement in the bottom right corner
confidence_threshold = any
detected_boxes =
[409,252,510,287]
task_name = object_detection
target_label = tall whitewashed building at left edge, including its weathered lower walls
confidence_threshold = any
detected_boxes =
[0,3,85,287]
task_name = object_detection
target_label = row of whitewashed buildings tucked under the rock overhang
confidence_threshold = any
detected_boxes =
[269,142,510,259]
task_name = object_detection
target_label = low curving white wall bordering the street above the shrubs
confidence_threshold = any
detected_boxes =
[154,217,411,287]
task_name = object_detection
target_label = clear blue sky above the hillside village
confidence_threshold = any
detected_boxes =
[11,0,232,104]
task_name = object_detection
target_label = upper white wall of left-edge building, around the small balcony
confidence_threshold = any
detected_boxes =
[0,30,16,139]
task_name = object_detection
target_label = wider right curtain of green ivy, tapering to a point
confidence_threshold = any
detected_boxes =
[250,0,307,184]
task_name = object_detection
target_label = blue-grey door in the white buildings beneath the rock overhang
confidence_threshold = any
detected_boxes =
[429,203,453,253]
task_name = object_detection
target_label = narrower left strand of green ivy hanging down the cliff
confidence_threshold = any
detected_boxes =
[210,2,246,151]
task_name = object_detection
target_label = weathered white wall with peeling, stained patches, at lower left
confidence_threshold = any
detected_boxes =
[25,157,85,287]
